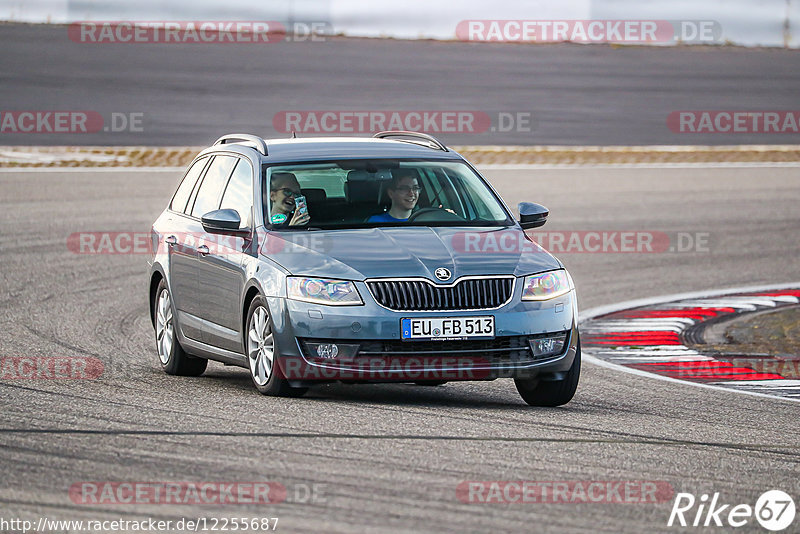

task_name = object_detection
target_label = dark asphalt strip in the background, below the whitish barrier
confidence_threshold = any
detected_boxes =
[0,24,800,146]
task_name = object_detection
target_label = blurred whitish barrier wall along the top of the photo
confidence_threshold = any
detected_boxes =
[0,0,800,48]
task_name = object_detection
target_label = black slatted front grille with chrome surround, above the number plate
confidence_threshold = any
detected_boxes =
[367,277,514,311]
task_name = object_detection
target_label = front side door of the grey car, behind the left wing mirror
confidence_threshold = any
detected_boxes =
[198,158,253,352]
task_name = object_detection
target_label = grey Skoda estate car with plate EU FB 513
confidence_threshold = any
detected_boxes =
[149,131,581,406]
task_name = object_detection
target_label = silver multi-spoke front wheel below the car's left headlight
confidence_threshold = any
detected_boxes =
[245,295,308,397]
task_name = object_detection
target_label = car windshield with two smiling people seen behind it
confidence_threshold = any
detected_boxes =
[263,159,513,230]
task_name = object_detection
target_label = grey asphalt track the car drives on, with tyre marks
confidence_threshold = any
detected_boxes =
[0,165,800,532]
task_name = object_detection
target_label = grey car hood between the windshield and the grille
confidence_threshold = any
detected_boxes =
[260,226,561,282]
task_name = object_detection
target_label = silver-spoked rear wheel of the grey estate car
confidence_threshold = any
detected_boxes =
[153,279,208,376]
